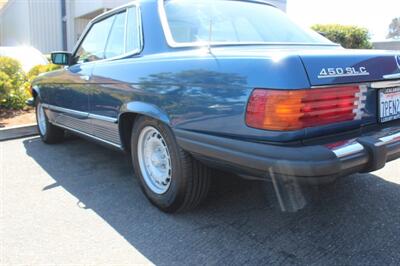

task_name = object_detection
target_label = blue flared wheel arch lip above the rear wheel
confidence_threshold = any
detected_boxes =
[118,101,170,125]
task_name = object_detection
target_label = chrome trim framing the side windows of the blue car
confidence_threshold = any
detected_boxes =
[72,1,144,65]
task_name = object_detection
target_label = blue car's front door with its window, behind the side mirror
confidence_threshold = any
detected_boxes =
[50,14,115,134]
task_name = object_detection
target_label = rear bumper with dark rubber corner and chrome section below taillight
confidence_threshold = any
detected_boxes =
[175,126,400,184]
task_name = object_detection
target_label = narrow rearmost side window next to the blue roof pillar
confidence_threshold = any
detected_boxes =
[125,7,140,53]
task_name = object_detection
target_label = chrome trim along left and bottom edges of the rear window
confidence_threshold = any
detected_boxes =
[157,0,340,48]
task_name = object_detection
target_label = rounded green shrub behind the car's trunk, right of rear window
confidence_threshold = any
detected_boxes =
[312,24,372,49]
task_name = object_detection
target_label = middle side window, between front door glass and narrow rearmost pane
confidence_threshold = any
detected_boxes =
[104,12,126,58]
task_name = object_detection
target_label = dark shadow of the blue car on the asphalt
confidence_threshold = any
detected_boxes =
[24,138,400,265]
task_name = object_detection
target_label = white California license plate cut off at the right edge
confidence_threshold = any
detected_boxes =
[379,87,400,123]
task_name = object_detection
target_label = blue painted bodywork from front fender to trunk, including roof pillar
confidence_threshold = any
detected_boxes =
[35,0,399,148]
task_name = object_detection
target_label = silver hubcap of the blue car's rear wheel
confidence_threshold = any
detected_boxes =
[137,126,172,194]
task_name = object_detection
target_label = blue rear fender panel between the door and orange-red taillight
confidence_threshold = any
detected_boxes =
[92,47,309,140]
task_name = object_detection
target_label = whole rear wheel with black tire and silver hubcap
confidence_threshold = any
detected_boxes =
[131,117,211,212]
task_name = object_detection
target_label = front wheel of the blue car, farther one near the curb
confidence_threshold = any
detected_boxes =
[36,99,64,144]
